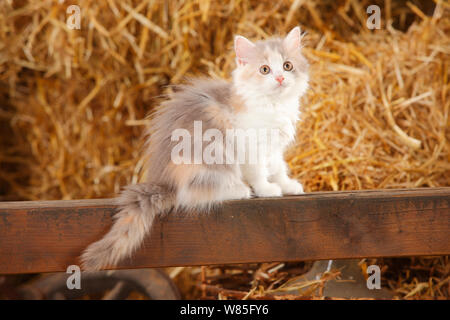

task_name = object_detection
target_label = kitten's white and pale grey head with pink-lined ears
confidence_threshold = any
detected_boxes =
[233,27,309,99]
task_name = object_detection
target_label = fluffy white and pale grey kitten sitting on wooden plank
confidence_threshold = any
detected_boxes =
[81,27,308,270]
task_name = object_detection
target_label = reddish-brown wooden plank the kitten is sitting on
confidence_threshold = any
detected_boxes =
[0,188,450,274]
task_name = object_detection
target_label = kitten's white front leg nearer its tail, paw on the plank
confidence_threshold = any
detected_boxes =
[241,164,282,197]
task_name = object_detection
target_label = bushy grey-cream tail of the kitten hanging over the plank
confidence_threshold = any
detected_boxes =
[81,184,174,271]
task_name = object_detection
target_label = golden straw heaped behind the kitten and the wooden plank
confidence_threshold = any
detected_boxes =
[0,0,450,299]
